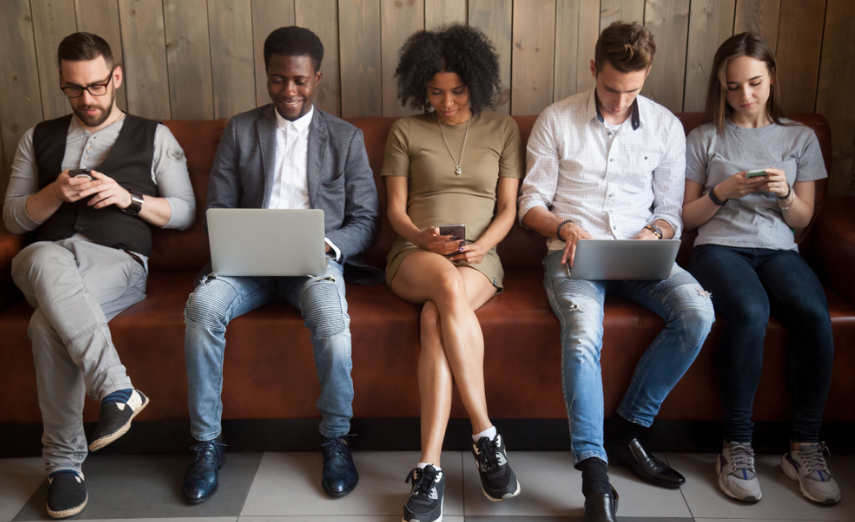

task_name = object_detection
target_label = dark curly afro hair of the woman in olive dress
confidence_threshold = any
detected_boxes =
[395,24,501,113]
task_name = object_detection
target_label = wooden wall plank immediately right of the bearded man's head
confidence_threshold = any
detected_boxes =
[119,0,172,120]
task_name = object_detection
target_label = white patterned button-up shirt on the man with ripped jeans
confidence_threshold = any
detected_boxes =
[519,89,686,250]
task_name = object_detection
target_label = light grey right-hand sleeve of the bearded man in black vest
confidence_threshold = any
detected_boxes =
[152,125,196,230]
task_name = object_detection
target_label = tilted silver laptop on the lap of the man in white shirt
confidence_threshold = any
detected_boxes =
[569,239,680,281]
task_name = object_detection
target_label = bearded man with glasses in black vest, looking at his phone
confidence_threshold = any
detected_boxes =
[3,33,196,518]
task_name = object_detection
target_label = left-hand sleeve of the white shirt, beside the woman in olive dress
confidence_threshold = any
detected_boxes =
[518,109,558,224]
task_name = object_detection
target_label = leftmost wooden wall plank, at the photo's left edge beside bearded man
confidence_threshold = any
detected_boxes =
[0,0,44,187]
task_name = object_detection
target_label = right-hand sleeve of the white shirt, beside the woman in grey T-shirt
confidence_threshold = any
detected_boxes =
[651,118,686,239]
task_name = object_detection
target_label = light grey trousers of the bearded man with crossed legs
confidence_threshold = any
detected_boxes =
[12,238,146,473]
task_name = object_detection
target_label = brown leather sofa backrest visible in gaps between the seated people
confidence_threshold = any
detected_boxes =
[150,112,831,270]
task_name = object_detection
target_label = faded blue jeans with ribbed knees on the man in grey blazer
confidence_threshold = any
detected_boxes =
[184,260,353,441]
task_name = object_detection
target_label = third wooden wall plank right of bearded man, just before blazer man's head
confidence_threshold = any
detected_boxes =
[208,0,256,118]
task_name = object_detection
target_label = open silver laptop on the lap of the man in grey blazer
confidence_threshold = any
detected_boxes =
[206,208,327,276]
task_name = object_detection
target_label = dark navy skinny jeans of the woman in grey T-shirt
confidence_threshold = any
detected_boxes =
[689,245,834,442]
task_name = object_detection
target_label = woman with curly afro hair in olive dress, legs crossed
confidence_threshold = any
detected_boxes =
[382,25,523,522]
